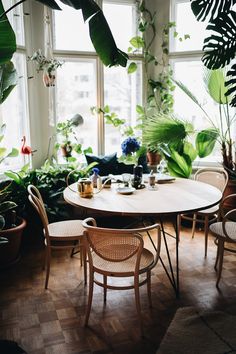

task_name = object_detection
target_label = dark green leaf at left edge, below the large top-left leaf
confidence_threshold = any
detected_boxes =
[0,61,18,104]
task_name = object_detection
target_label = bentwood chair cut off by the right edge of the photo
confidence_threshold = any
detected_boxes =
[210,194,236,287]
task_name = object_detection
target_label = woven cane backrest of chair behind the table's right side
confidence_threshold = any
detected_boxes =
[194,168,228,193]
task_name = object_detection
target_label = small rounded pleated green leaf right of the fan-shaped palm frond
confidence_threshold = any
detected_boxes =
[195,128,219,157]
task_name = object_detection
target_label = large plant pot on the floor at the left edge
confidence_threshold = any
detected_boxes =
[0,218,26,269]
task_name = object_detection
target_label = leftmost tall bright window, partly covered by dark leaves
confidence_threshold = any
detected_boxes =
[0,0,29,172]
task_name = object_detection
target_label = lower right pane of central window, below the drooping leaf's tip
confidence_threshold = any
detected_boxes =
[104,62,142,154]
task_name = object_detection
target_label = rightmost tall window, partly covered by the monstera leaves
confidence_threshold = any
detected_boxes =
[170,0,225,164]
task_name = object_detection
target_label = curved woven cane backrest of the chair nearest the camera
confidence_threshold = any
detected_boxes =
[82,218,161,269]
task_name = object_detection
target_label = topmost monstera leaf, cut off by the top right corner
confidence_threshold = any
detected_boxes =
[191,0,236,21]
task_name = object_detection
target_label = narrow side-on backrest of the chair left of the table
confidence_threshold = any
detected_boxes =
[27,184,48,237]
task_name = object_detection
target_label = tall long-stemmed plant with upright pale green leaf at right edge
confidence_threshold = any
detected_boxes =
[175,68,236,179]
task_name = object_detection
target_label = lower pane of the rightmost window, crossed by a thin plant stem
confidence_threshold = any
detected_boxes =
[173,59,229,163]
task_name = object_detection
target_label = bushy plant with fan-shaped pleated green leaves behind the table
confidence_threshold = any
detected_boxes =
[143,113,218,178]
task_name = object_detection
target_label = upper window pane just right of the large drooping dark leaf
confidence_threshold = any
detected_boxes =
[103,2,137,51]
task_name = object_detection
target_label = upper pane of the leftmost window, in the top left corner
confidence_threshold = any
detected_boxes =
[3,0,25,45]
